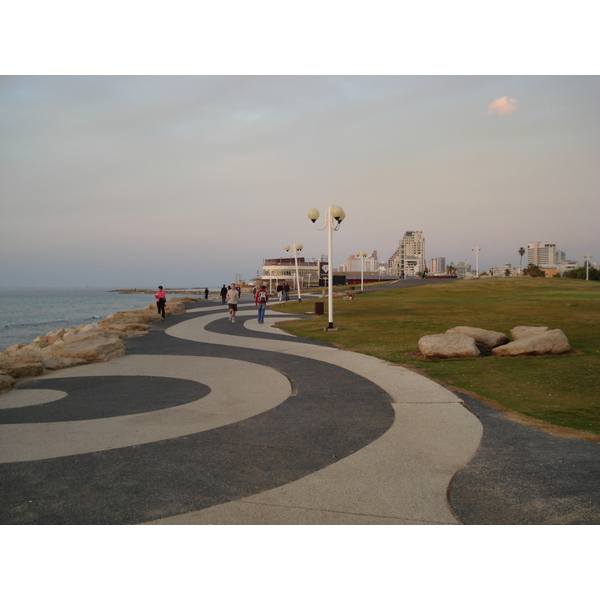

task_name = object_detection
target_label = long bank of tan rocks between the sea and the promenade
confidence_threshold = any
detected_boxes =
[0,297,197,393]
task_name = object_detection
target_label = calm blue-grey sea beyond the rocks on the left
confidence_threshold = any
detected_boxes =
[0,287,162,351]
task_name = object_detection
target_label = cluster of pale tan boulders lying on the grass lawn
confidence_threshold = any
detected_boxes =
[419,326,571,359]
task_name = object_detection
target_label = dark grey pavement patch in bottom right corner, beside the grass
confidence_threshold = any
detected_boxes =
[449,393,600,525]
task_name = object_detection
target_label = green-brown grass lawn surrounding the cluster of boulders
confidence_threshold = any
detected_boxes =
[273,277,600,441]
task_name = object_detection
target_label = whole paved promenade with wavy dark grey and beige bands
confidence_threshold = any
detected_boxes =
[0,295,600,525]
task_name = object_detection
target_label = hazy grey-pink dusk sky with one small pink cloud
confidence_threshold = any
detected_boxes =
[0,75,600,287]
